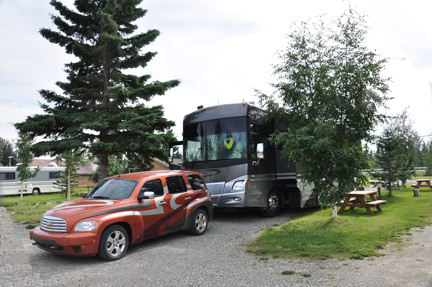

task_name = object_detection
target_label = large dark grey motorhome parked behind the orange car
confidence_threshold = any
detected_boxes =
[172,103,313,216]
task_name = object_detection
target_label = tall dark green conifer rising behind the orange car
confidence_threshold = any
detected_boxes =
[16,0,180,182]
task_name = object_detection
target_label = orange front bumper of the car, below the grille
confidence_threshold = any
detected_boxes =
[30,227,98,256]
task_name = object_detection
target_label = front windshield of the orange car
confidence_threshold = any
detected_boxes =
[87,178,138,199]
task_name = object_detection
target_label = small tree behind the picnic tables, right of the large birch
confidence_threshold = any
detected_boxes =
[373,109,419,195]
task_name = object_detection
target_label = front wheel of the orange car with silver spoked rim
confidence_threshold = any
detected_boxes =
[98,225,129,261]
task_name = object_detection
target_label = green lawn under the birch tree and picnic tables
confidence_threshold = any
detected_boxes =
[248,188,432,259]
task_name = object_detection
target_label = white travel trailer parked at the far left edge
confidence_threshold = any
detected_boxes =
[0,166,65,196]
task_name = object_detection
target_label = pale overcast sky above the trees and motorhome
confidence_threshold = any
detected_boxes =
[0,0,432,144]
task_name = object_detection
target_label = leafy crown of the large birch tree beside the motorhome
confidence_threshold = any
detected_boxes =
[260,9,388,214]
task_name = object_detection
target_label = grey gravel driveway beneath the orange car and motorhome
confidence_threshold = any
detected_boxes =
[0,207,432,286]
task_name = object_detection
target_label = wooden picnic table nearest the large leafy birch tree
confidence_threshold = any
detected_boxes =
[339,190,387,215]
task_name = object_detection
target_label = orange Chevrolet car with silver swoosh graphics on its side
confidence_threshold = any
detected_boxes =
[30,171,213,260]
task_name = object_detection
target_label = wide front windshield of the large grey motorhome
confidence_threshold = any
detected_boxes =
[183,118,247,162]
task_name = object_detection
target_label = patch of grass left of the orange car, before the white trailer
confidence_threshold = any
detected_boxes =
[0,188,87,228]
